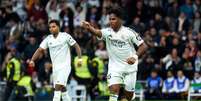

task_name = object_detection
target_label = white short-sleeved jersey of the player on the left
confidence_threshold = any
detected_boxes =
[40,32,76,72]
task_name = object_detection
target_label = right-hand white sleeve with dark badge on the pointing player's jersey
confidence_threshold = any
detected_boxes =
[129,30,144,46]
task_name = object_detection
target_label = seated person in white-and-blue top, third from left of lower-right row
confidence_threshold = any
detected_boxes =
[176,70,190,99]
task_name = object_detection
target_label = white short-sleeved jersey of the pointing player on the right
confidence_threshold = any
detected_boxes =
[101,26,144,72]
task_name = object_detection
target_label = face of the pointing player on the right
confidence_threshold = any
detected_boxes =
[109,14,120,29]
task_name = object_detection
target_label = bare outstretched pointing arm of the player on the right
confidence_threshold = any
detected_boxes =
[81,21,102,38]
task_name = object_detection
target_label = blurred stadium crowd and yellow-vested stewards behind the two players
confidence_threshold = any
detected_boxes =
[0,0,201,99]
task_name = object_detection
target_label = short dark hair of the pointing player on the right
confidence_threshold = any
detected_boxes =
[108,6,123,19]
